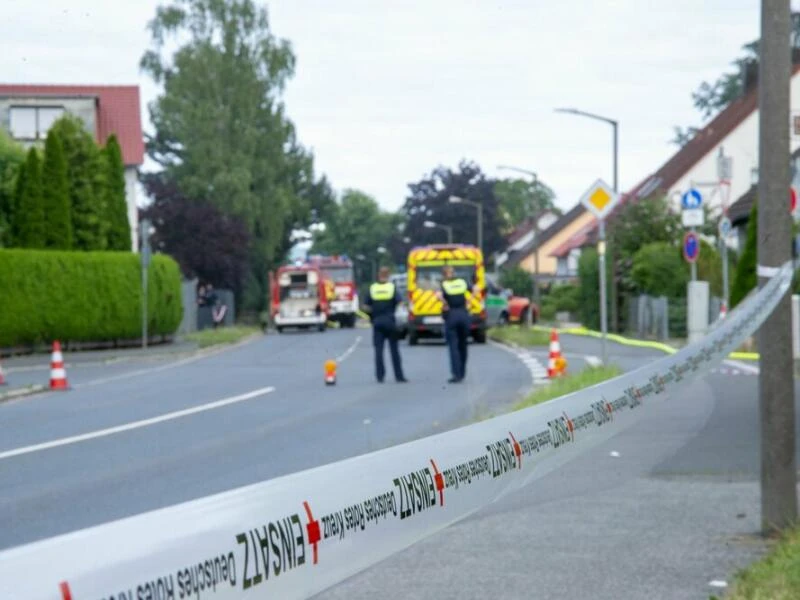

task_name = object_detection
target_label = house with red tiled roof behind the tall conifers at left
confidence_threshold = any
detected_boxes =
[0,84,144,248]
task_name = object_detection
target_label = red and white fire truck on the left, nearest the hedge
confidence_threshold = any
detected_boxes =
[270,264,330,333]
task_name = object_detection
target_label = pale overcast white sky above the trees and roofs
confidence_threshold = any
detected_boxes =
[0,0,788,209]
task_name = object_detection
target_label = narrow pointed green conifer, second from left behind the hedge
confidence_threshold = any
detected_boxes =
[42,129,72,250]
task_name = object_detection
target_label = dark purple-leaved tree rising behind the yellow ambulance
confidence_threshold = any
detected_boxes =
[401,161,505,259]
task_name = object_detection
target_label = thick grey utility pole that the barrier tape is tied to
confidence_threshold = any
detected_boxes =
[758,0,797,533]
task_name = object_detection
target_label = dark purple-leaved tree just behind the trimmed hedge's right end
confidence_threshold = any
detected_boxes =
[141,174,250,295]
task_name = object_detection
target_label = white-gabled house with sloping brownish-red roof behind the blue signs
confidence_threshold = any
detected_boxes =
[553,59,800,261]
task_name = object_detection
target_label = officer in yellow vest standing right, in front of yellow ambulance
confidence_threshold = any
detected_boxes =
[439,266,470,383]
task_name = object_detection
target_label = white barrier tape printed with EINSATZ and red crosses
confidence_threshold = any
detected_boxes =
[0,264,792,600]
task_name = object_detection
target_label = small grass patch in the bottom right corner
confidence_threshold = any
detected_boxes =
[725,529,800,600]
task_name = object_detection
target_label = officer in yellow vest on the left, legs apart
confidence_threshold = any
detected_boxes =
[366,267,408,383]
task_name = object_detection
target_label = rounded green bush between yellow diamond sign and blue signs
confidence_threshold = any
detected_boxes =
[631,242,689,298]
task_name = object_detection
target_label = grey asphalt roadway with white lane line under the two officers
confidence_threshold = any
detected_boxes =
[0,329,531,548]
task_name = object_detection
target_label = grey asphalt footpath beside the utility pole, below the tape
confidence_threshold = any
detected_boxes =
[318,336,800,600]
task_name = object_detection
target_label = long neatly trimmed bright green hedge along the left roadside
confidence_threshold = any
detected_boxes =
[0,250,183,347]
